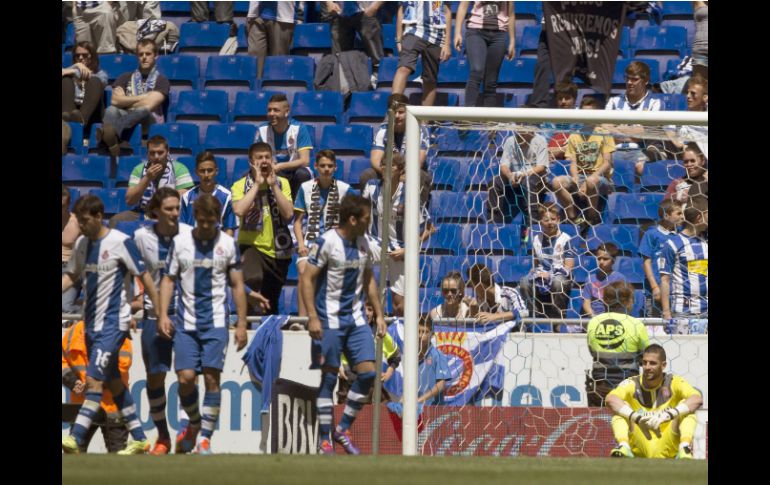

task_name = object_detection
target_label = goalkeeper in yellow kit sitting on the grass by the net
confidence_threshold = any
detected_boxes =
[606,344,703,458]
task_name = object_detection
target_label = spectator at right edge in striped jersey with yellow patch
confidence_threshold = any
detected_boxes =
[660,196,709,333]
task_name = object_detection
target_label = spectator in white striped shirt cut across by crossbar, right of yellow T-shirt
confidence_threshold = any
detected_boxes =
[604,61,663,175]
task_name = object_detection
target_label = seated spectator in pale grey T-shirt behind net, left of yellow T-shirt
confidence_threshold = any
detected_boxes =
[489,126,548,228]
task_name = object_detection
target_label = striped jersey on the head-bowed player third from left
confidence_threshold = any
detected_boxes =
[167,231,241,332]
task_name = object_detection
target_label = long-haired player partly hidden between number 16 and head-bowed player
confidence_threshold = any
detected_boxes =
[134,187,192,455]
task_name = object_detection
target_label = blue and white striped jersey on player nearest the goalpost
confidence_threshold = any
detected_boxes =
[308,229,372,329]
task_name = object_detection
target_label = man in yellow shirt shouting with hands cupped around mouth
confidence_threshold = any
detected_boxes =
[232,142,294,315]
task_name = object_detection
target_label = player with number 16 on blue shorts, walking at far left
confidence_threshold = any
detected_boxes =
[61,195,158,455]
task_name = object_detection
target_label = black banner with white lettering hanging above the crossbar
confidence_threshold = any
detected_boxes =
[543,2,626,95]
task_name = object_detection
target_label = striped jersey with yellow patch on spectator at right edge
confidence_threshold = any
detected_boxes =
[658,233,709,315]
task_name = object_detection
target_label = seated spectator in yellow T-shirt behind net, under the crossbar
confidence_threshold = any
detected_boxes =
[552,97,615,224]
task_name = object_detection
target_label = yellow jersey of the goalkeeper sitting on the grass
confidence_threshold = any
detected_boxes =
[609,374,700,411]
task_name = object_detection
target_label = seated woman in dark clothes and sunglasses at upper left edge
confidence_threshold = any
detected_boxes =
[61,41,108,126]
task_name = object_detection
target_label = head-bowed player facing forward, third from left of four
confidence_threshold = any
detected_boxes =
[158,194,247,455]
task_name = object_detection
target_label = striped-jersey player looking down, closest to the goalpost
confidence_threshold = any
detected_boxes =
[300,194,386,455]
